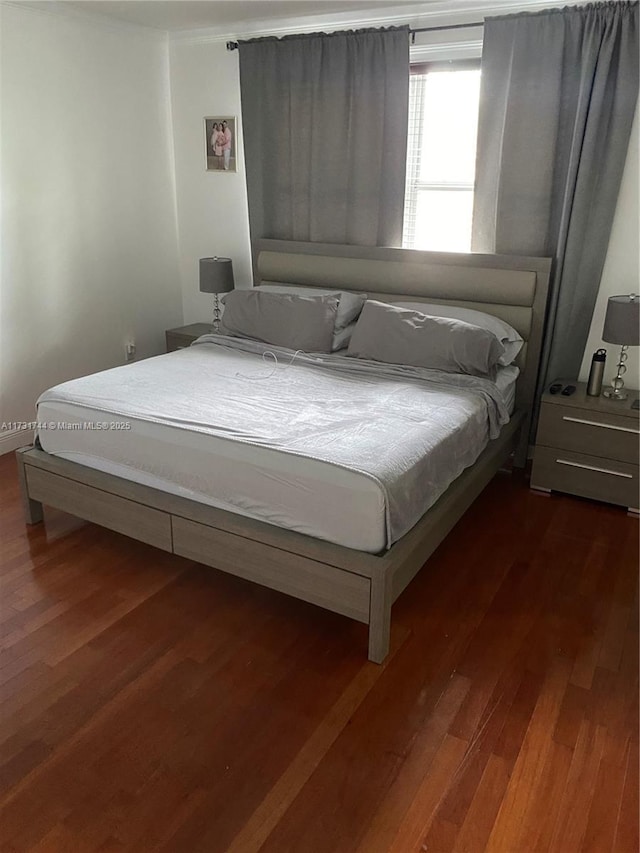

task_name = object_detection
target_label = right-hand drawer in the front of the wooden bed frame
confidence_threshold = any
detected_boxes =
[172,516,371,623]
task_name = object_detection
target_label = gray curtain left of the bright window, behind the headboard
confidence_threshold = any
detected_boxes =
[239,27,409,246]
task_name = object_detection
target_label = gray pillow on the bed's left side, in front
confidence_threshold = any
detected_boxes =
[220,290,339,352]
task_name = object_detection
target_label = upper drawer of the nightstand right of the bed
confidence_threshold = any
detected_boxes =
[536,405,640,467]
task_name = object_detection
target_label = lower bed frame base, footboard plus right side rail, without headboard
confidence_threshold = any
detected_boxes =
[16,415,522,663]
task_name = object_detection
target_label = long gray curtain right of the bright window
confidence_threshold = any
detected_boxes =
[472,2,638,402]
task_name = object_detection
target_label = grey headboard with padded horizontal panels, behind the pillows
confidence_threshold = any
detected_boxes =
[253,240,551,440]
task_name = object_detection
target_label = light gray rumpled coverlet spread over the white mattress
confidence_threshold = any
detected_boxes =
[38,335,508,544]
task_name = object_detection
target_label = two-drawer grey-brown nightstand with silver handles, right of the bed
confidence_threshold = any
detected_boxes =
[531,379,640,512]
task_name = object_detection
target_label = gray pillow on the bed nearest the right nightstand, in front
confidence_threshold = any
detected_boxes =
[347,300,504,376]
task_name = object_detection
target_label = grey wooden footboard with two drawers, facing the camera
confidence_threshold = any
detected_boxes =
[16,447,391,663]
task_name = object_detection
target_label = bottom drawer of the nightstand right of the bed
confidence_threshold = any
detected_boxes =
[531,450,640,509]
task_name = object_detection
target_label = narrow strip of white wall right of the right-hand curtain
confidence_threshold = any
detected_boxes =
[580,100,640,389]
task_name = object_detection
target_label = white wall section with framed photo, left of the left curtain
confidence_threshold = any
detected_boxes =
[170,36,251,323]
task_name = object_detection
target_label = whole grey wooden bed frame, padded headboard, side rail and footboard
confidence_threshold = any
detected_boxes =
[17,240,551,663]
